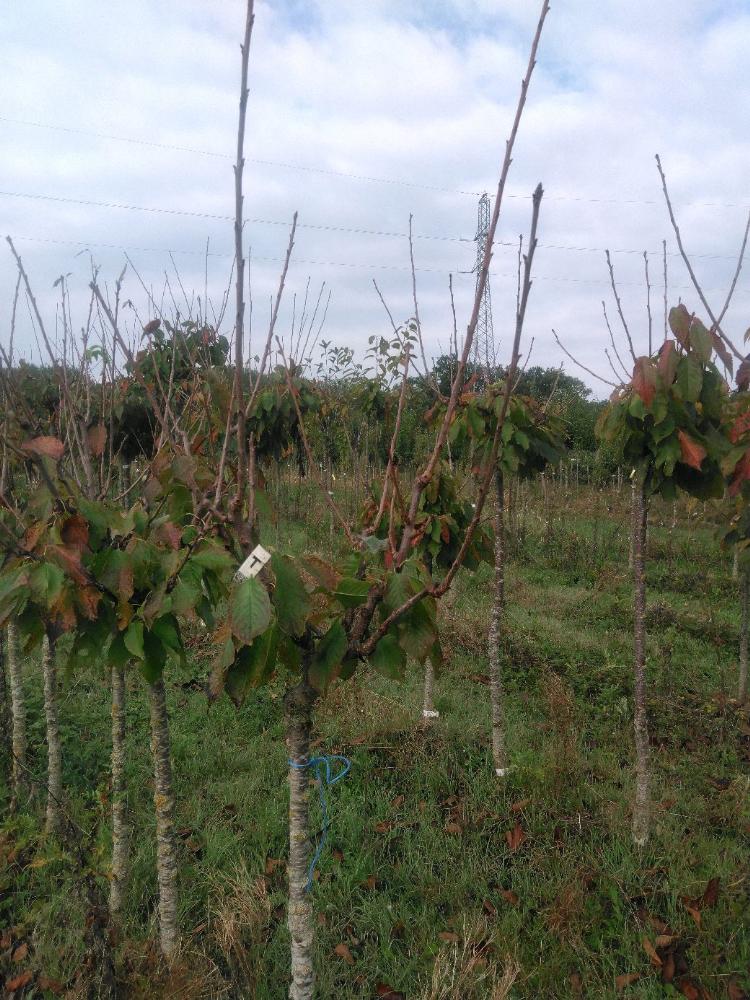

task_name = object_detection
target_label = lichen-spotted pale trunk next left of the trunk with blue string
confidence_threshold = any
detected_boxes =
[149,677,179,962]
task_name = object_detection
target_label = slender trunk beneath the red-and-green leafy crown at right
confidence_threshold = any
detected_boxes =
[633,481,651,847]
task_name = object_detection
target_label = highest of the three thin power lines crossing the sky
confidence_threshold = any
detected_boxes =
[0,115,750,210]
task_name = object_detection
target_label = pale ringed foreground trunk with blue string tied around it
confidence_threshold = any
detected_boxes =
[284,680,316,1000]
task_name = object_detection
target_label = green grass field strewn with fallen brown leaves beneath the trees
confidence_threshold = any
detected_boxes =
[0,489,750,1000]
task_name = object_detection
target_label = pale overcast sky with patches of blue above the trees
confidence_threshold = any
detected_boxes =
[0,0,750,394]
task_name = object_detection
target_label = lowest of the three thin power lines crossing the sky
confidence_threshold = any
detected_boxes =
[14,235,750,295]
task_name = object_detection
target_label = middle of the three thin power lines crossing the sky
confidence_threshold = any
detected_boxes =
[0,191,748,261]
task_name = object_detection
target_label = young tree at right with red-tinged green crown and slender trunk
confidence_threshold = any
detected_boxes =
[597,306,728,846]
